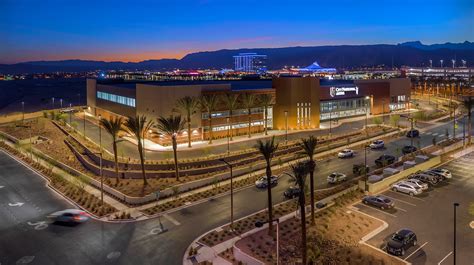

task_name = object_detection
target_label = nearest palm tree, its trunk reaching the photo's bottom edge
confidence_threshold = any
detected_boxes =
[290,161,311,264]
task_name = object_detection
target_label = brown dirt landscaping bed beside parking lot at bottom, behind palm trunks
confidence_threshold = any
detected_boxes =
[233,192,403,265]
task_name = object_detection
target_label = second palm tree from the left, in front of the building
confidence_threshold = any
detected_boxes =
[124,115,153,186]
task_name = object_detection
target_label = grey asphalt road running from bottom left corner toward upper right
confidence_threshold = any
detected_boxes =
[0,118,466,265]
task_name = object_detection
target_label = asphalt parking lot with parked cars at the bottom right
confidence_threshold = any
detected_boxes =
[354,152,474,265]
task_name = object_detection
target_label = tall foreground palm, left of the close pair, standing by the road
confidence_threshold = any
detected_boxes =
[255,136,278,236]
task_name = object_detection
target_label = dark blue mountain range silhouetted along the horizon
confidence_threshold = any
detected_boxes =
[0,41,474,74]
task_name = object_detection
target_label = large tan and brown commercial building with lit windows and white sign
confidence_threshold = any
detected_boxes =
[87,77,411,143]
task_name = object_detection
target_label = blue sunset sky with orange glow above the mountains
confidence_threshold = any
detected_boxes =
[0,0,474,63]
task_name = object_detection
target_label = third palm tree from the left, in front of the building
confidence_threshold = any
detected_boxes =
[155,115,186,181]
